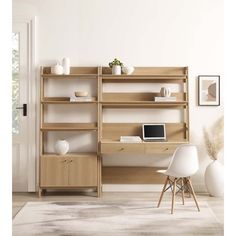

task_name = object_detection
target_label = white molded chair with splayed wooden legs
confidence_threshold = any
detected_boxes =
[157,145,200,214]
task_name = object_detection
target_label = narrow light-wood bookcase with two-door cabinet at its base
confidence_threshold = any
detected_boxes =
[39,67,101,196]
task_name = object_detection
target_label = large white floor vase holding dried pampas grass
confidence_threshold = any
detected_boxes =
[205,160,224,197]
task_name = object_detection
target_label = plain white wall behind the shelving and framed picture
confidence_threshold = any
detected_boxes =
[13,0,224,190]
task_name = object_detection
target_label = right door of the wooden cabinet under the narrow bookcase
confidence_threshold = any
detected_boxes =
[69,155,98,187]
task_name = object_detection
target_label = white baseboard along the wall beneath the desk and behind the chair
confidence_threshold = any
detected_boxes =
[102,184,206,193]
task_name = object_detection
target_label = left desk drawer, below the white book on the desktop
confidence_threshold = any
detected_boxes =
[101,143,145,153]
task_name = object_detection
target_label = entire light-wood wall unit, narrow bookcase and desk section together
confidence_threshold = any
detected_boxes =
[39,67,190,196]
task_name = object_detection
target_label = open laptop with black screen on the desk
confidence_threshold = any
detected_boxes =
[142,124,166,141]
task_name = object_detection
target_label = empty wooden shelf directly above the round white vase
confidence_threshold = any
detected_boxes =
[41,123,97,131]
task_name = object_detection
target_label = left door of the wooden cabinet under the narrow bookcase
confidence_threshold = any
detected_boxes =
[40,157,68,187]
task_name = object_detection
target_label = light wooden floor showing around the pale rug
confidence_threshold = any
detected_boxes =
[12,192,224,224]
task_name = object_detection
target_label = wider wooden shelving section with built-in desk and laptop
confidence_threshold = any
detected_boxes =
[98,67,189,184]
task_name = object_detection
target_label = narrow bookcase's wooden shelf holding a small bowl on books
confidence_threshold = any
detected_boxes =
[41,97,97,104]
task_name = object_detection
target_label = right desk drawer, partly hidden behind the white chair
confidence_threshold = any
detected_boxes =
[145,143,178,154]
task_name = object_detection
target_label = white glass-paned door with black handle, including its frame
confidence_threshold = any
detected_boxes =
[12,20,35,192]
